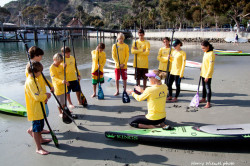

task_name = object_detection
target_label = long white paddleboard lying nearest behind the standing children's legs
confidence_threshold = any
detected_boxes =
[104,72,202,92]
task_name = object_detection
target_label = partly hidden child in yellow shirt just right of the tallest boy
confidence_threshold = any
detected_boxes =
[157,37,173,85]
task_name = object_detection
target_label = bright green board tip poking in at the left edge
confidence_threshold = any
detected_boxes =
[0,96,27,116]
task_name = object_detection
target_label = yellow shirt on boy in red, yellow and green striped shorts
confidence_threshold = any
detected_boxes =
[91,50,106,73]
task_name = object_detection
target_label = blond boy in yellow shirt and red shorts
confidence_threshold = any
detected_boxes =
[112,33,129,96]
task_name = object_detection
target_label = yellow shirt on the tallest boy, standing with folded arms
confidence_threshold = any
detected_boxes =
[131,40,150,69]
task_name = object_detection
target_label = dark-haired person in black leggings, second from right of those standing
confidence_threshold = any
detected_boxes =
[167,39,186,102]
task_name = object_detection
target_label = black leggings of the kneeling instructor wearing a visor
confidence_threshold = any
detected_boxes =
[129,115,166,127]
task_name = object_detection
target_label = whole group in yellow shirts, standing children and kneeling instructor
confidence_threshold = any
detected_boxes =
[25,29,215,155]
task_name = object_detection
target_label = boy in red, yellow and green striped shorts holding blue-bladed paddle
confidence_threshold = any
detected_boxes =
[91,43,106,98]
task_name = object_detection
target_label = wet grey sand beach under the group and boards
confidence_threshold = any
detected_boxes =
[0,44,250,166]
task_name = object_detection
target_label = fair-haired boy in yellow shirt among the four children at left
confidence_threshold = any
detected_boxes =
[49,53,69,118]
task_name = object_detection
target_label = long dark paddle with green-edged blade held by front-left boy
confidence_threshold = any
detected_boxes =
[19,33,59,147]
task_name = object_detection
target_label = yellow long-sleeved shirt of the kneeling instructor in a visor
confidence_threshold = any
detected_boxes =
[132,84,168,120]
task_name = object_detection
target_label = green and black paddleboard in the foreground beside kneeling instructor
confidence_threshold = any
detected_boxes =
[105,124,250,143]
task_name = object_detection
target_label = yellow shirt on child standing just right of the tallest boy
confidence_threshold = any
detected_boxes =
[157,47,174,71]
